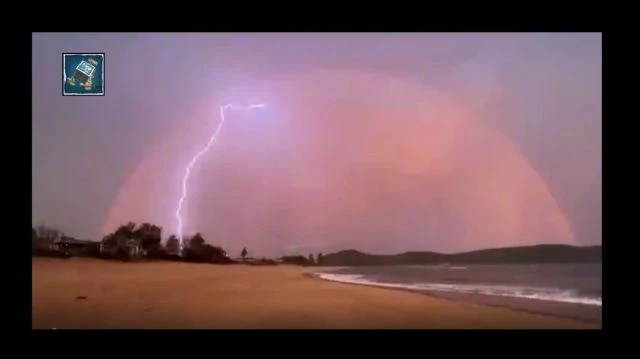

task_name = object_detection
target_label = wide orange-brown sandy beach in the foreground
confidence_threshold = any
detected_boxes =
[32,258,600,329]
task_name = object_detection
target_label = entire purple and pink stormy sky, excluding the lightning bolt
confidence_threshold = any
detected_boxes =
[32,33,602,255]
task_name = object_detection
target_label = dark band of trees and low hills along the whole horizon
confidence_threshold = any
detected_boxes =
[31,222,602,266]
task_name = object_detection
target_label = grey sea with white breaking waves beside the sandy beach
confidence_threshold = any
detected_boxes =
[316,264,602,323]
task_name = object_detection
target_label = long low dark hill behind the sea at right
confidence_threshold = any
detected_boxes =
[322,244,602,266]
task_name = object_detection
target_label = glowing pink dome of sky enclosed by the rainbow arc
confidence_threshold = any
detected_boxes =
[104,71,575,254]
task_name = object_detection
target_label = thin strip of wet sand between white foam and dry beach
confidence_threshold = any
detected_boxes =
[303,272,602,326]
